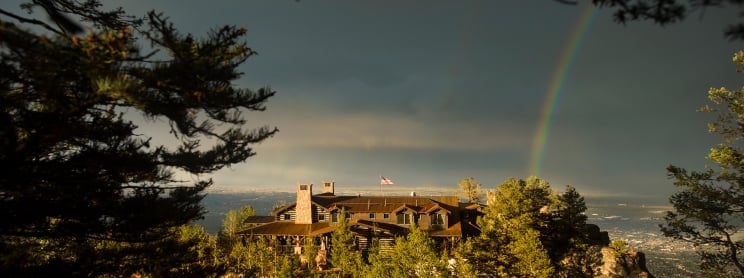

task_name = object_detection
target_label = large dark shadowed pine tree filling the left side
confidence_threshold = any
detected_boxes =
[0,0,276,276]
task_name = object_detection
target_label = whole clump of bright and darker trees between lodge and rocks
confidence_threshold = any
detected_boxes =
[457,177,588,277]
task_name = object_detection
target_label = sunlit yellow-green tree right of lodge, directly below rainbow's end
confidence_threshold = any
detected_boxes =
[464,177,554,277]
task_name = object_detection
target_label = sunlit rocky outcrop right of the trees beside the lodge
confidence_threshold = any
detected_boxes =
[587,225,654,278]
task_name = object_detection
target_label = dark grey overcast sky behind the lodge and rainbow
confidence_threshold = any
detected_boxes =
[8,0,741,202]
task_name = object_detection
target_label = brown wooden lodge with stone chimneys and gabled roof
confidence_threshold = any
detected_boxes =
[240,181,482,261]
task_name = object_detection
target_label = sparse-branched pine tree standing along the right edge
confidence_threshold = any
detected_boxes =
[661,52,744,275]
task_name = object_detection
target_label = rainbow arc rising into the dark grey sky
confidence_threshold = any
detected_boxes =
[529,5,597,175]
